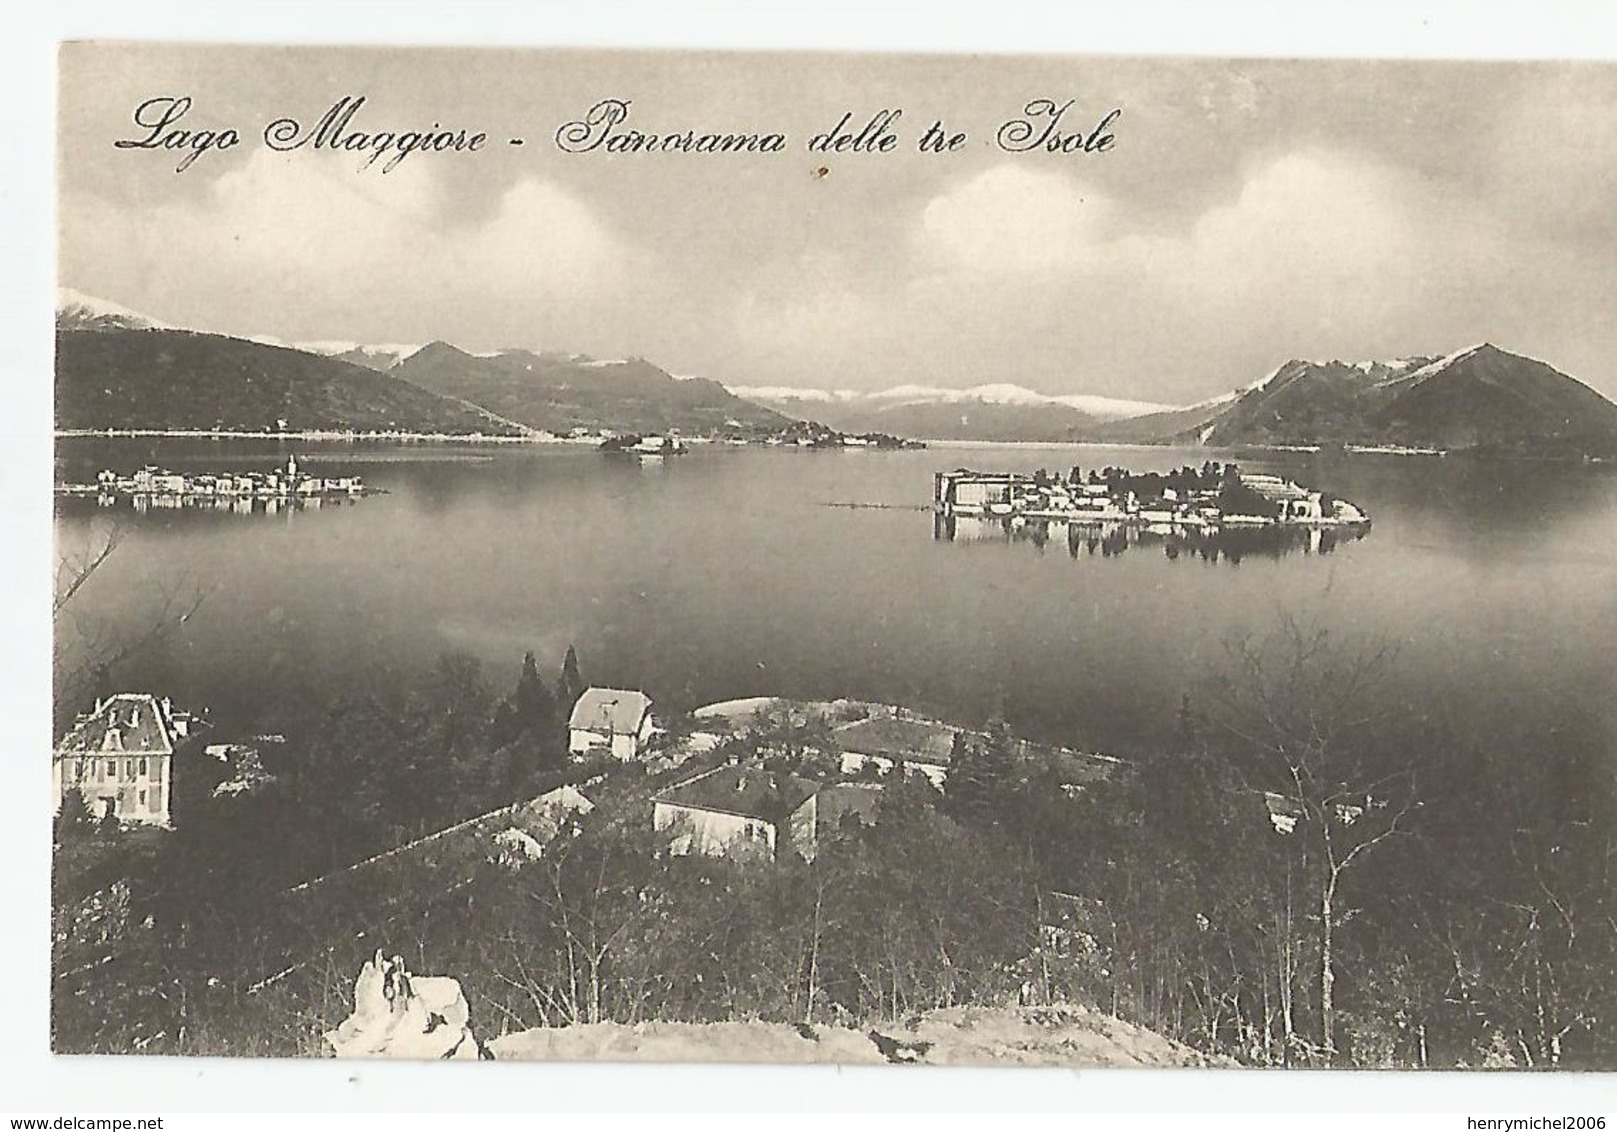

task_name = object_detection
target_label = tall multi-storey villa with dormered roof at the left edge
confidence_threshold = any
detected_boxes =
[50,692,205,826]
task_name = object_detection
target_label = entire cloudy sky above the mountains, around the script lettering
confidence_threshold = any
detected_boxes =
[58,45,1617,403]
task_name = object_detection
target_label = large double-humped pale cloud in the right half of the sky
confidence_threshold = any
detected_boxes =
[730,147,1539,401]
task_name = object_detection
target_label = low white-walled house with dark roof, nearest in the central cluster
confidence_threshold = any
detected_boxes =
[652,767,820,860]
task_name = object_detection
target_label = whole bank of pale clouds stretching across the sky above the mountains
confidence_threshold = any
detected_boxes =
[61,122,1617,403]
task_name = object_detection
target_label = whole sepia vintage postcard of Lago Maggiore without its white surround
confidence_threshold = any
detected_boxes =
[50,42,1617,1067]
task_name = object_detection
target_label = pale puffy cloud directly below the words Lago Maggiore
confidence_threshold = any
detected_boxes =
[61,149,639,340]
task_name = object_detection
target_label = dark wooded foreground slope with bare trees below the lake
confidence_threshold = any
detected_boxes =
[53,631,1617,1067]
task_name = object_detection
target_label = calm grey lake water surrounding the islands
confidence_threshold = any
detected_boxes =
[57,440,1617,766]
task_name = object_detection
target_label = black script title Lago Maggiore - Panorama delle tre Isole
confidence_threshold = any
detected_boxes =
[113,94,1122,173]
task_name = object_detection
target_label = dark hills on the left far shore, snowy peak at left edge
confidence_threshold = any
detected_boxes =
[57,289,794,435]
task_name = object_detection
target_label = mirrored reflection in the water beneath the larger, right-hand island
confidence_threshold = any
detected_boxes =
[931,514,1370,566]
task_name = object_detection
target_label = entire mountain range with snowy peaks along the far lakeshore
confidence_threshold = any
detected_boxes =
[57,289,1617,456]
